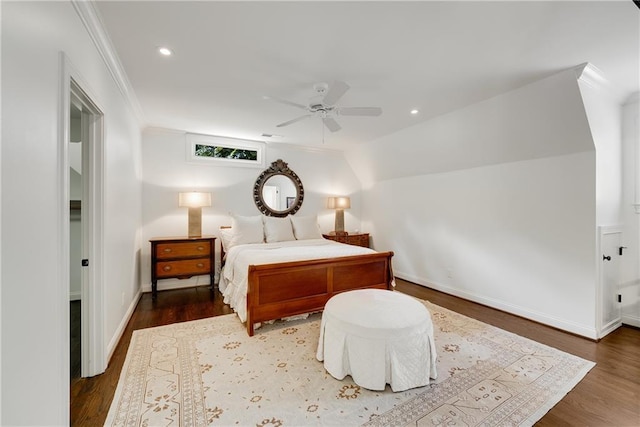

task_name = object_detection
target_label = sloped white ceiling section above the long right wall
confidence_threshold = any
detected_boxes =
[347,68,595,187]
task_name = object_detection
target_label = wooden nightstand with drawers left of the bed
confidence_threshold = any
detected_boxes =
[149,236,216,300]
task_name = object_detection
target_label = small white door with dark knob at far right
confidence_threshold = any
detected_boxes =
[599,227,622,338]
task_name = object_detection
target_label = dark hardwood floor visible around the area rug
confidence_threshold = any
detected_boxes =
[71,280,640,427]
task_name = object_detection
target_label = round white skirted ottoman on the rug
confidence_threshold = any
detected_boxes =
[316,289,437,392]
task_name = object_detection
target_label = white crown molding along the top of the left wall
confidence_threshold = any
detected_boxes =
[71,0,146,127]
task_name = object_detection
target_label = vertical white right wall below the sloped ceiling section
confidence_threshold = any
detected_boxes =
[364,153,595,336]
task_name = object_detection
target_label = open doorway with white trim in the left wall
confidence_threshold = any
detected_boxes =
[60,65,106,379]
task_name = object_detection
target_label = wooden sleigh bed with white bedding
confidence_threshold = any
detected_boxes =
[219,218,393,336]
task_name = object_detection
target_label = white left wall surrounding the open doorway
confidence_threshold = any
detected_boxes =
[0,2,141,425]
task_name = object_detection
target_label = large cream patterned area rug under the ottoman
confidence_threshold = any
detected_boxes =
[105,302,594,427]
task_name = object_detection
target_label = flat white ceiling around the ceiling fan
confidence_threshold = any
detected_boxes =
[96,0,640,149]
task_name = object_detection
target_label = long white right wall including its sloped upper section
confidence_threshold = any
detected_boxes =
[347,70,596,337]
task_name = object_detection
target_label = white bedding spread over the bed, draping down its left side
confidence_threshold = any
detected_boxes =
[220,239,375,322]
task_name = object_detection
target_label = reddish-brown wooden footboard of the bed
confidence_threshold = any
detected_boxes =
[247,252,393,336]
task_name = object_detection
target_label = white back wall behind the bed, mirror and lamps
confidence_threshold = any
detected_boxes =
[141,129,361,291]
